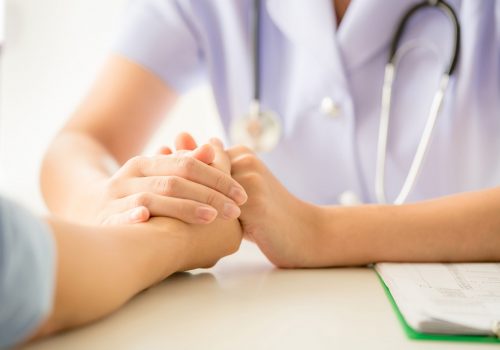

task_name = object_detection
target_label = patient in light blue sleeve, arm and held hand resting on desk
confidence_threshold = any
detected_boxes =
[0,141,241,348]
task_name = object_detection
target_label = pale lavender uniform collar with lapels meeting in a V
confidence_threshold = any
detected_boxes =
[266,0,419,70]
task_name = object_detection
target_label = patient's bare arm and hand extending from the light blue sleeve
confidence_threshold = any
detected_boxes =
[31,218,241,338]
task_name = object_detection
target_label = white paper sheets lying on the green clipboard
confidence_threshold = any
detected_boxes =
[375,263,500,336]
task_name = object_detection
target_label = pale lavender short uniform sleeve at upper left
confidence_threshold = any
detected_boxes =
[112,0,205,93]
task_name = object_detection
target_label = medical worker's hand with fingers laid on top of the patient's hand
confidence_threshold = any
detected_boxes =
[93,135,247,225]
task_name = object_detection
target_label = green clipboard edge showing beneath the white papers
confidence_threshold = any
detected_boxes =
[374,269,500,343]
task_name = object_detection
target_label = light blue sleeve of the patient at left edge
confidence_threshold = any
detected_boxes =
[0,198,55,349]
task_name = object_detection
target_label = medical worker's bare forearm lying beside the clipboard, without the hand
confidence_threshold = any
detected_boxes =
[318,188,500,266]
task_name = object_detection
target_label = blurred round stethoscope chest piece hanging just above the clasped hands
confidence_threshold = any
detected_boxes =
[230,101,281,152]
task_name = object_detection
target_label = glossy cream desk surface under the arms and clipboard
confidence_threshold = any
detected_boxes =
[26,243,498,350]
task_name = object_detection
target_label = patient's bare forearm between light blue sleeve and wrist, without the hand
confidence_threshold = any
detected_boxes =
[33,220,185,335]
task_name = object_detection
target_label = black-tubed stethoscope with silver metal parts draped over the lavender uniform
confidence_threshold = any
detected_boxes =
[230,0,460,204]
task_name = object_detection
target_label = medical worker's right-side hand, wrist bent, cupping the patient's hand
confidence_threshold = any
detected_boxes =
[227,146,320,268]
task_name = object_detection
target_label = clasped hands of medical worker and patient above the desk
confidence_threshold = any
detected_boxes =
[96,134,321,269]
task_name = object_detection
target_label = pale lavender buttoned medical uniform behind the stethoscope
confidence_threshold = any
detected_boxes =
[115,0,500,204]
